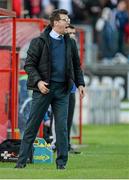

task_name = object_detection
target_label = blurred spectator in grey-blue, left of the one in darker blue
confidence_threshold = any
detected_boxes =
[96,8,117,59]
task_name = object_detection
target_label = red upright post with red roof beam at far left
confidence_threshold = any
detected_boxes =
[0,8,18,138]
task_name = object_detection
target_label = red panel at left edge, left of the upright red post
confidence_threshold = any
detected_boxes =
[0,49,12,143]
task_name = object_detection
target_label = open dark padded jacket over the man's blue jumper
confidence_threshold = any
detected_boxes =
[24,25,85,90]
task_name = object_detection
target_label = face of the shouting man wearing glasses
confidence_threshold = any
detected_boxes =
[54,14,70,34]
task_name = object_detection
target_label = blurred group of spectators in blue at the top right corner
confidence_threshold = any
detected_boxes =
[95,0,129,60]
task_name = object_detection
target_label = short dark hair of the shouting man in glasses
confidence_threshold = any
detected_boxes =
[49,9,68,26]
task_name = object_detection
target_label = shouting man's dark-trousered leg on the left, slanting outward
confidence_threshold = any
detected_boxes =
[16,92,51,167]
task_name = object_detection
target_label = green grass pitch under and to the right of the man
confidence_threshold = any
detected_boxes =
[0,124,129,179]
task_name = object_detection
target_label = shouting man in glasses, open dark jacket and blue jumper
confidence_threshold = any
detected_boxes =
[16,9,85,170]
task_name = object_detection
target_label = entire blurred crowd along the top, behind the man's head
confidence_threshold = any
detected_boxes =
[10,0,129,60]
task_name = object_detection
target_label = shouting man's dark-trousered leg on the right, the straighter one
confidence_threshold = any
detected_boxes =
[52,85,69,166]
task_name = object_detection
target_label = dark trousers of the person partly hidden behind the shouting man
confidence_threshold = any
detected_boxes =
[67,93,75,150]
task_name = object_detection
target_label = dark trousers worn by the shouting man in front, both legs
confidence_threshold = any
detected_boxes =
[17,82,69,165]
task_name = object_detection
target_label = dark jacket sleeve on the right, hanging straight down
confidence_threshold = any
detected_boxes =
[71,39,85,87]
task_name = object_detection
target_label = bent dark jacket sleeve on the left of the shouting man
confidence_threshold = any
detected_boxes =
[24,38,43,86]
